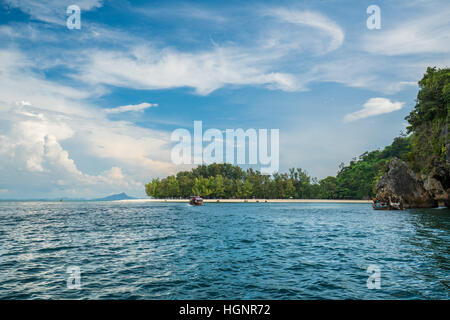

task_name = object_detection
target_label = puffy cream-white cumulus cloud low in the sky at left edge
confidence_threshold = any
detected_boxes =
[0,110,142,188]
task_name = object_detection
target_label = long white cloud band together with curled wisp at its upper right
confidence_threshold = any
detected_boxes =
[66,9,344,95]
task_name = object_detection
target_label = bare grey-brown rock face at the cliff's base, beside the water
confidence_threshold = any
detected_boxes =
[376,158,450,208]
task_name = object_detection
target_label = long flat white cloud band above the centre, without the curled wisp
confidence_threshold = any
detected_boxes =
[79,47,298,95]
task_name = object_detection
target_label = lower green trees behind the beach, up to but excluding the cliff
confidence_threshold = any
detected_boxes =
[145,137,409,199]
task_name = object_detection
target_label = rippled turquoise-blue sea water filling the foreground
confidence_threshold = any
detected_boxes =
[0,202,450,299]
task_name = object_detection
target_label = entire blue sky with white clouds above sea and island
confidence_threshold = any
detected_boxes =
[0,0,450,199]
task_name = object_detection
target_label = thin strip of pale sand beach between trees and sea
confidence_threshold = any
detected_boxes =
[114,199,372,203]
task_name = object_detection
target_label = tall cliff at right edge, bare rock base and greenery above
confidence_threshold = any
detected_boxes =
[376,68,450,208]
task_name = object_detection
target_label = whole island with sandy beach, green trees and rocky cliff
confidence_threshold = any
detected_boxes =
[145,67,450,208]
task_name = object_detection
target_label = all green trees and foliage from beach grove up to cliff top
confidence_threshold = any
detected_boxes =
[145,68,450,199]
